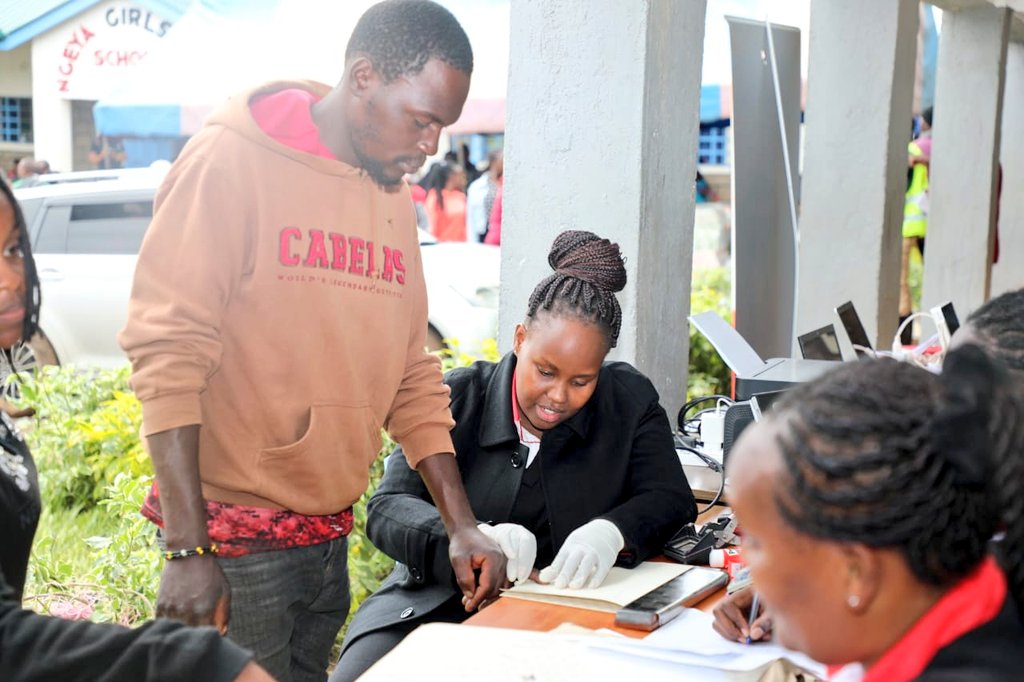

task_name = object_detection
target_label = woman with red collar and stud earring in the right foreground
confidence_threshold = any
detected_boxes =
[716,345,1024,682]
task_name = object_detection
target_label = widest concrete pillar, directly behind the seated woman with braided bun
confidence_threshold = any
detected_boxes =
[499,0,706,415]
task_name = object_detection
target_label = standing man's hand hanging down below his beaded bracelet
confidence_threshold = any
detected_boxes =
[157,556,231,635]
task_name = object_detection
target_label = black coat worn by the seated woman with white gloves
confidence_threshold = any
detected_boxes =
[342,353,696,651]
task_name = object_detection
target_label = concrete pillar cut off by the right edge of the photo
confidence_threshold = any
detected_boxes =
[991,43,1024,294]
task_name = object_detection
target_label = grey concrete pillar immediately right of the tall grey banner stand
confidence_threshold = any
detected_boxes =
[797,0,919,347]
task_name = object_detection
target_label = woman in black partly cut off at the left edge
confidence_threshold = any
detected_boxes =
[0,180,271,682]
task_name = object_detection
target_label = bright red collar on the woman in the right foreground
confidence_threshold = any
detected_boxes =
[829,557,1007,682]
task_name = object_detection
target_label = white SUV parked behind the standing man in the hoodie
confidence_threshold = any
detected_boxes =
[11,168,500,386]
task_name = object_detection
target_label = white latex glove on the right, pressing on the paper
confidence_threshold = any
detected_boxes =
[540,518,626,590]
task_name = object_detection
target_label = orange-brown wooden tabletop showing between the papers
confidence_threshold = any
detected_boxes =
[464,507,728,639]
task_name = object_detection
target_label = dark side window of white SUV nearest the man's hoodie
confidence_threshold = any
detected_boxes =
[66,202,153,254]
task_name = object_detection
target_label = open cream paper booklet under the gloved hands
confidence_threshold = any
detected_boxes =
[502,561,692,613]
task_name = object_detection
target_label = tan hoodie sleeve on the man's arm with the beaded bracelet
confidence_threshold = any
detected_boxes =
[118,131,251,435]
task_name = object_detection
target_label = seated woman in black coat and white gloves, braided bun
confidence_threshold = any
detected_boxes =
[331,231,696,682]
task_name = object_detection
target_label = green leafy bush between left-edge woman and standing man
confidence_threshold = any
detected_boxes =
[19,367,160,624]
